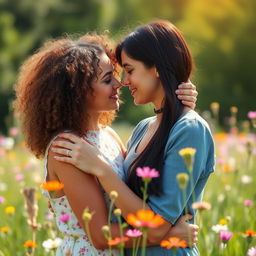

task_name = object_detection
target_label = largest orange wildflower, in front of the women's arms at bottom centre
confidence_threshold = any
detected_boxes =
[127,210,164,228]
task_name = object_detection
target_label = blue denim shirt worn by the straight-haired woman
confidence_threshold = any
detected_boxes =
[124,110,215,256]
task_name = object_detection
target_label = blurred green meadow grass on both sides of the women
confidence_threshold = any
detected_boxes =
[0,125,256,256]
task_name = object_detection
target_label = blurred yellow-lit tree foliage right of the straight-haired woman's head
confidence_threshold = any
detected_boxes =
[177,0,256,119]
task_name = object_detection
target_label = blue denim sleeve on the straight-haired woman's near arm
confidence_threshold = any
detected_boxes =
[148,119,215,224]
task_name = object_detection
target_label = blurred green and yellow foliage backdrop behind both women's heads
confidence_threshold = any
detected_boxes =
[0,0,256,132]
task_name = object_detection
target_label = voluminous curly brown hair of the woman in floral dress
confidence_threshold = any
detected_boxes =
[14,34,116,158]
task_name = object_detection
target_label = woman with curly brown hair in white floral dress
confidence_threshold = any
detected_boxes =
[15,35,198,255]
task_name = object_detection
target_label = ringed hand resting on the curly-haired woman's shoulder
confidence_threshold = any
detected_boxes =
[51,133,105,176]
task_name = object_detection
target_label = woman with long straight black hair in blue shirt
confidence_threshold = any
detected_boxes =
[54,21,214,256]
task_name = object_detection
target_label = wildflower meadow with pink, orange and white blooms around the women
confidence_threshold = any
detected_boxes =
[0,108,256,256]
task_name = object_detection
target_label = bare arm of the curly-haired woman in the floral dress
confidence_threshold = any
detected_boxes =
[48,144,123,249]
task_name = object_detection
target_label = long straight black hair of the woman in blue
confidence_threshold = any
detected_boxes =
[116,20,193,197]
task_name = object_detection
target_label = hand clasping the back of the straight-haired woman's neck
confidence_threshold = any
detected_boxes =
[175,81,198,109]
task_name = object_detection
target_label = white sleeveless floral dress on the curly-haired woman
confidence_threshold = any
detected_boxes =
[43,128,124,256]
